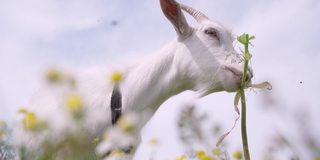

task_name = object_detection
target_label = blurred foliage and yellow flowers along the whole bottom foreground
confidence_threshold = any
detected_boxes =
[0,70,320,160]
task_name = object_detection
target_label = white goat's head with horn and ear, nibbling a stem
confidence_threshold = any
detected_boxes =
[160,0,252,96]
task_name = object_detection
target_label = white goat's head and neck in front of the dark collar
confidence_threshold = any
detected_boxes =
[114,0,252,125]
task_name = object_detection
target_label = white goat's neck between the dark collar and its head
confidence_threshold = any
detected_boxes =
[121,44,189,119]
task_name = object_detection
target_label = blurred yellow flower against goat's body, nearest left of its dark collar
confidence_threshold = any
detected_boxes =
[66,95,83,118]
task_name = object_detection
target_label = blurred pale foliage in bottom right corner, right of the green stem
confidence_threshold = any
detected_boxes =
[263,108,320,160]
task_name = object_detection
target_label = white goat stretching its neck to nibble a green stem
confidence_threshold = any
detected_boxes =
[15,0,252,158]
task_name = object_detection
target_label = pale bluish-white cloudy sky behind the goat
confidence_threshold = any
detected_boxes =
[0,0,320,159]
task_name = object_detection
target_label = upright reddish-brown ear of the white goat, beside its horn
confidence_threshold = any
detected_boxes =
[160,0,192,36]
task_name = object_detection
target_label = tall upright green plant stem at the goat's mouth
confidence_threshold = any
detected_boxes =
[240,36,250,160]
